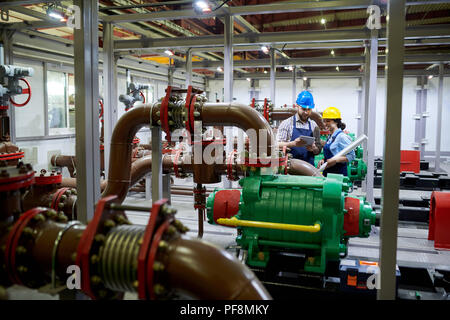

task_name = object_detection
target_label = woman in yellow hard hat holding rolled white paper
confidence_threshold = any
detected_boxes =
[318,107,355,177]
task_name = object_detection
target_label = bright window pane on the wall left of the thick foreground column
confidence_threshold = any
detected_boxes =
[47,71,75,135]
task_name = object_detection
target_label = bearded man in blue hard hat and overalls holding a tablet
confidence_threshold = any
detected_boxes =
[277,91,322,165]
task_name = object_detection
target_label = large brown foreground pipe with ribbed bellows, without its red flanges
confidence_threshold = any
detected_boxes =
[0,208,271,300]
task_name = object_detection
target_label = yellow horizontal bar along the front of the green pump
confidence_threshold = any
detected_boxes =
[217,217,321,233]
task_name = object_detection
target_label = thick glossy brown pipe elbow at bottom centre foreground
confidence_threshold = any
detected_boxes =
[163,236,272,300]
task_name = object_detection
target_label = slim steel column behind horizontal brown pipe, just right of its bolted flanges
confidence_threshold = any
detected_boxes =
[223,15,234,188]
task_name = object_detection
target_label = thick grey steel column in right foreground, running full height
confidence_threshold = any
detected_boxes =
[378,0,405,300]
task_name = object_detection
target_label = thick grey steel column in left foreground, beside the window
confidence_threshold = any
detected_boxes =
[74,0,100,223]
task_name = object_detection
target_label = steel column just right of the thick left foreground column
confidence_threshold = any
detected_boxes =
[103,23,118,179]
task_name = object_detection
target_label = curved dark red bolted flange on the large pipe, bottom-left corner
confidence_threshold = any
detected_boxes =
[4,208,59,288]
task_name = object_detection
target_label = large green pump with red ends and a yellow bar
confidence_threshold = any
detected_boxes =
[207,170,375,274]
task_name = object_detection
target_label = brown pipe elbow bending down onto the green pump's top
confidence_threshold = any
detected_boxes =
[201,102,276,157]
